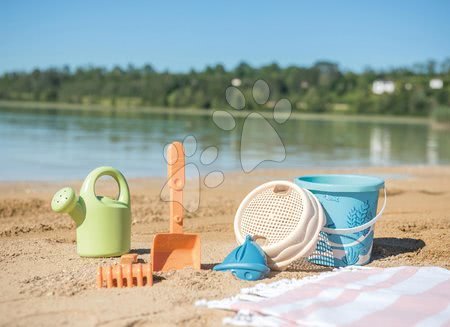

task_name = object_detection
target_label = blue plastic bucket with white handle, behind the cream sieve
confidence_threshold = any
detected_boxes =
[295,175,386,267]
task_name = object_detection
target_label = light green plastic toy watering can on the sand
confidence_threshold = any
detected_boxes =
[52,167,131,257]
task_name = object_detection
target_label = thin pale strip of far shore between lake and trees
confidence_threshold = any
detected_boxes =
[0,100,431,125]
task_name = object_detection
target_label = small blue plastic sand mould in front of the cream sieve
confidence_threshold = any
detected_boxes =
[213,235,270,280]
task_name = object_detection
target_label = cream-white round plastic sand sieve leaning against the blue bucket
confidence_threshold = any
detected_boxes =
[234,181,325,270]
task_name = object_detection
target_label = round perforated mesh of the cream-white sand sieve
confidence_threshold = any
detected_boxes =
[240,188,303,245]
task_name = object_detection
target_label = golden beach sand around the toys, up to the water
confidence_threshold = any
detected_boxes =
[0,167,450,326]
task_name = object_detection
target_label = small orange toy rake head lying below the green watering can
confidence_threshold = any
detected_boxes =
[97,255,153,288]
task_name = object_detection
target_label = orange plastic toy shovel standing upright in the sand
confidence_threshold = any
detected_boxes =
[152,142,201,271]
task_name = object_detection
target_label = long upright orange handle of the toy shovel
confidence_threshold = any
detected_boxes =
[167,142,185,233]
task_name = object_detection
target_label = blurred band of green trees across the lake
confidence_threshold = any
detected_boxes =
[0,58,450,116]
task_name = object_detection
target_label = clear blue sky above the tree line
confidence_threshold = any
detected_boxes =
[0,0,450,73]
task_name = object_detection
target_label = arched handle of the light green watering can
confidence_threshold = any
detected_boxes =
[80,167,130,205]
